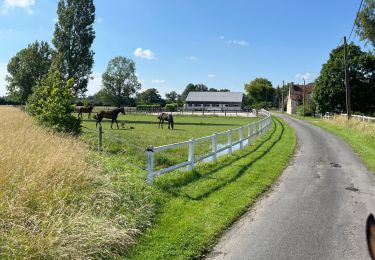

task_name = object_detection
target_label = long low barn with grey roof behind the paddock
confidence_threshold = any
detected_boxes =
[185,92,243,111]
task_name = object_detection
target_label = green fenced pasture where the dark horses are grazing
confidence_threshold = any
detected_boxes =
[82,114,258,170]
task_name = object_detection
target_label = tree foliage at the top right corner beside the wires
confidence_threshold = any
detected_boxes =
[355,0,375,47]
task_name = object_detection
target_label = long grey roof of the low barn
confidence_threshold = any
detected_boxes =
[186,91,243,103]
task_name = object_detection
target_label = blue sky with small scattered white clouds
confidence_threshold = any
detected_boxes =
[0,0,366,96]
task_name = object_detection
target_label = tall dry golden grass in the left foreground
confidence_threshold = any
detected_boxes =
[0,107,137,259]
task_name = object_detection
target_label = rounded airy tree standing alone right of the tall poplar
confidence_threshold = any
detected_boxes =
[102,56,141,107]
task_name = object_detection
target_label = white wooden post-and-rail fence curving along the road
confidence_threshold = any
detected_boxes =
[146,110,272,184]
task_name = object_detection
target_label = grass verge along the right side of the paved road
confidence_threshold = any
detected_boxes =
[304,117,375,173]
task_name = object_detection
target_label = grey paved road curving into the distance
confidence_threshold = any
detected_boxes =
[208,115,375,259]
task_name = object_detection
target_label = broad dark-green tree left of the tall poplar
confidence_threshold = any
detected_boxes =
[6,41,53,103]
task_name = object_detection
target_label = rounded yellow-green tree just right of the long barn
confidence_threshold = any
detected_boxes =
[245,78,275,103]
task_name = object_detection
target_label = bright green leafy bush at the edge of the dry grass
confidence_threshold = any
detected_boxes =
[27,72,81,135]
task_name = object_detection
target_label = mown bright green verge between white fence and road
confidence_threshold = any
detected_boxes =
[125,118,296,259]
